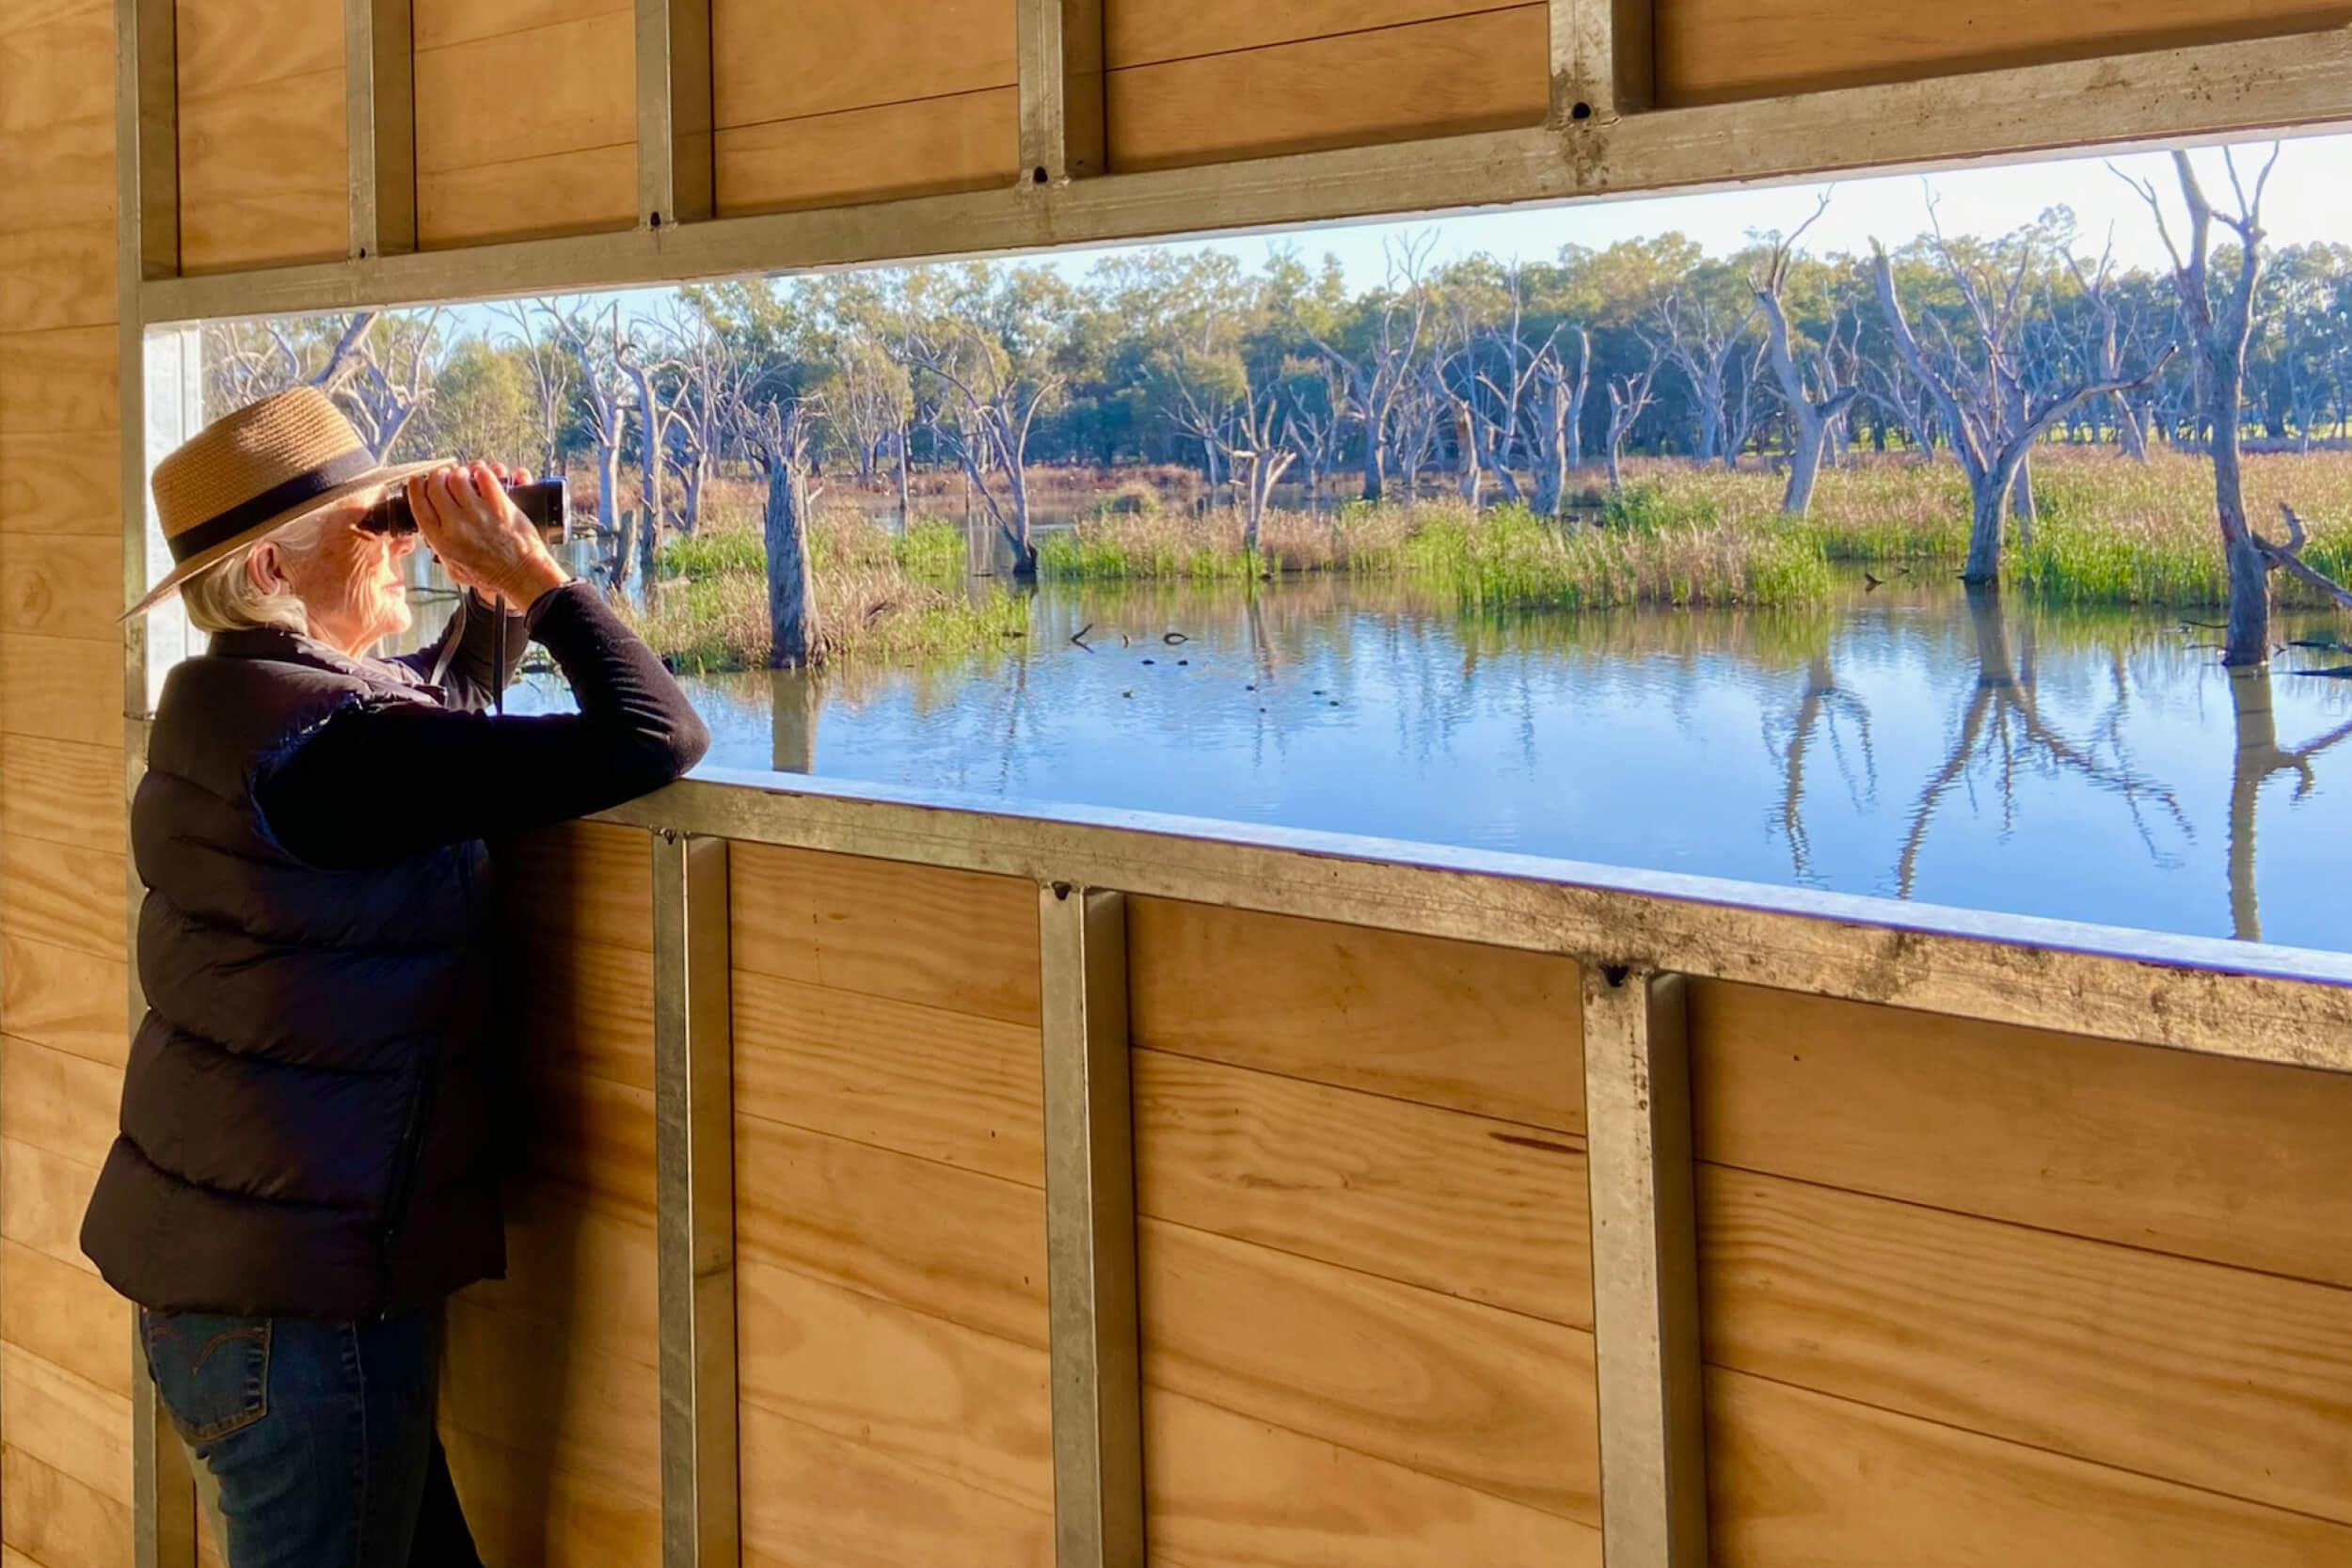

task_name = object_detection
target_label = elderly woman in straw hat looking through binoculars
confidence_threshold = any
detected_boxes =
[83,388,708,1568]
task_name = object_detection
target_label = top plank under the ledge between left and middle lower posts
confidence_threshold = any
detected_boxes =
[729,844,1038,1025]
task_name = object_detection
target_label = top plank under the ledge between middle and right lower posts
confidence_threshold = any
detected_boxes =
[1127,898,1585,1133]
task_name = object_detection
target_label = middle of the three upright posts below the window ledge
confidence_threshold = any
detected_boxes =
[1038,881,1143,1568]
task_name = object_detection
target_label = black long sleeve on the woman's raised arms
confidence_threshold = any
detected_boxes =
[257,583,710,870]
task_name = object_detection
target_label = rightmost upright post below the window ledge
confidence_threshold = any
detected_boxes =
[1583,969,1708,1568]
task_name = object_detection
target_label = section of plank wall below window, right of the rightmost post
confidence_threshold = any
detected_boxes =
[1692,985,2352,1568]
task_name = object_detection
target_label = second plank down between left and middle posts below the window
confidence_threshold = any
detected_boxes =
[734,969,1044,1187]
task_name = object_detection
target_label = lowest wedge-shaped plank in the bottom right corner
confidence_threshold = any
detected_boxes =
[1708,1370,2352,1568]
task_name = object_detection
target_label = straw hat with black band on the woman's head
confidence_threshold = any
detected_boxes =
[122,386,440,621]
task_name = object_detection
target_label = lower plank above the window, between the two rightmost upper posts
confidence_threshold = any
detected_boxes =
[1105,5,1550,171]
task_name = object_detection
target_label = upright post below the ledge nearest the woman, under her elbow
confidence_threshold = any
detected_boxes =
[654,830,739,1568]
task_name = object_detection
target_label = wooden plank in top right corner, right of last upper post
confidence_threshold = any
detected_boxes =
[1656,0,2352,103]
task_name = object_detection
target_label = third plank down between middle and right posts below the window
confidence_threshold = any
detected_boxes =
[1136,1220,1599,1524]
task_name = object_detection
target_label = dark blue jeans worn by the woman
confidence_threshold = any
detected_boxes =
[139,1307,483,1568]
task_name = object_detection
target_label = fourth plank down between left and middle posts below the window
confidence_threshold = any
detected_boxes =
[737,1260,1054,1512]
